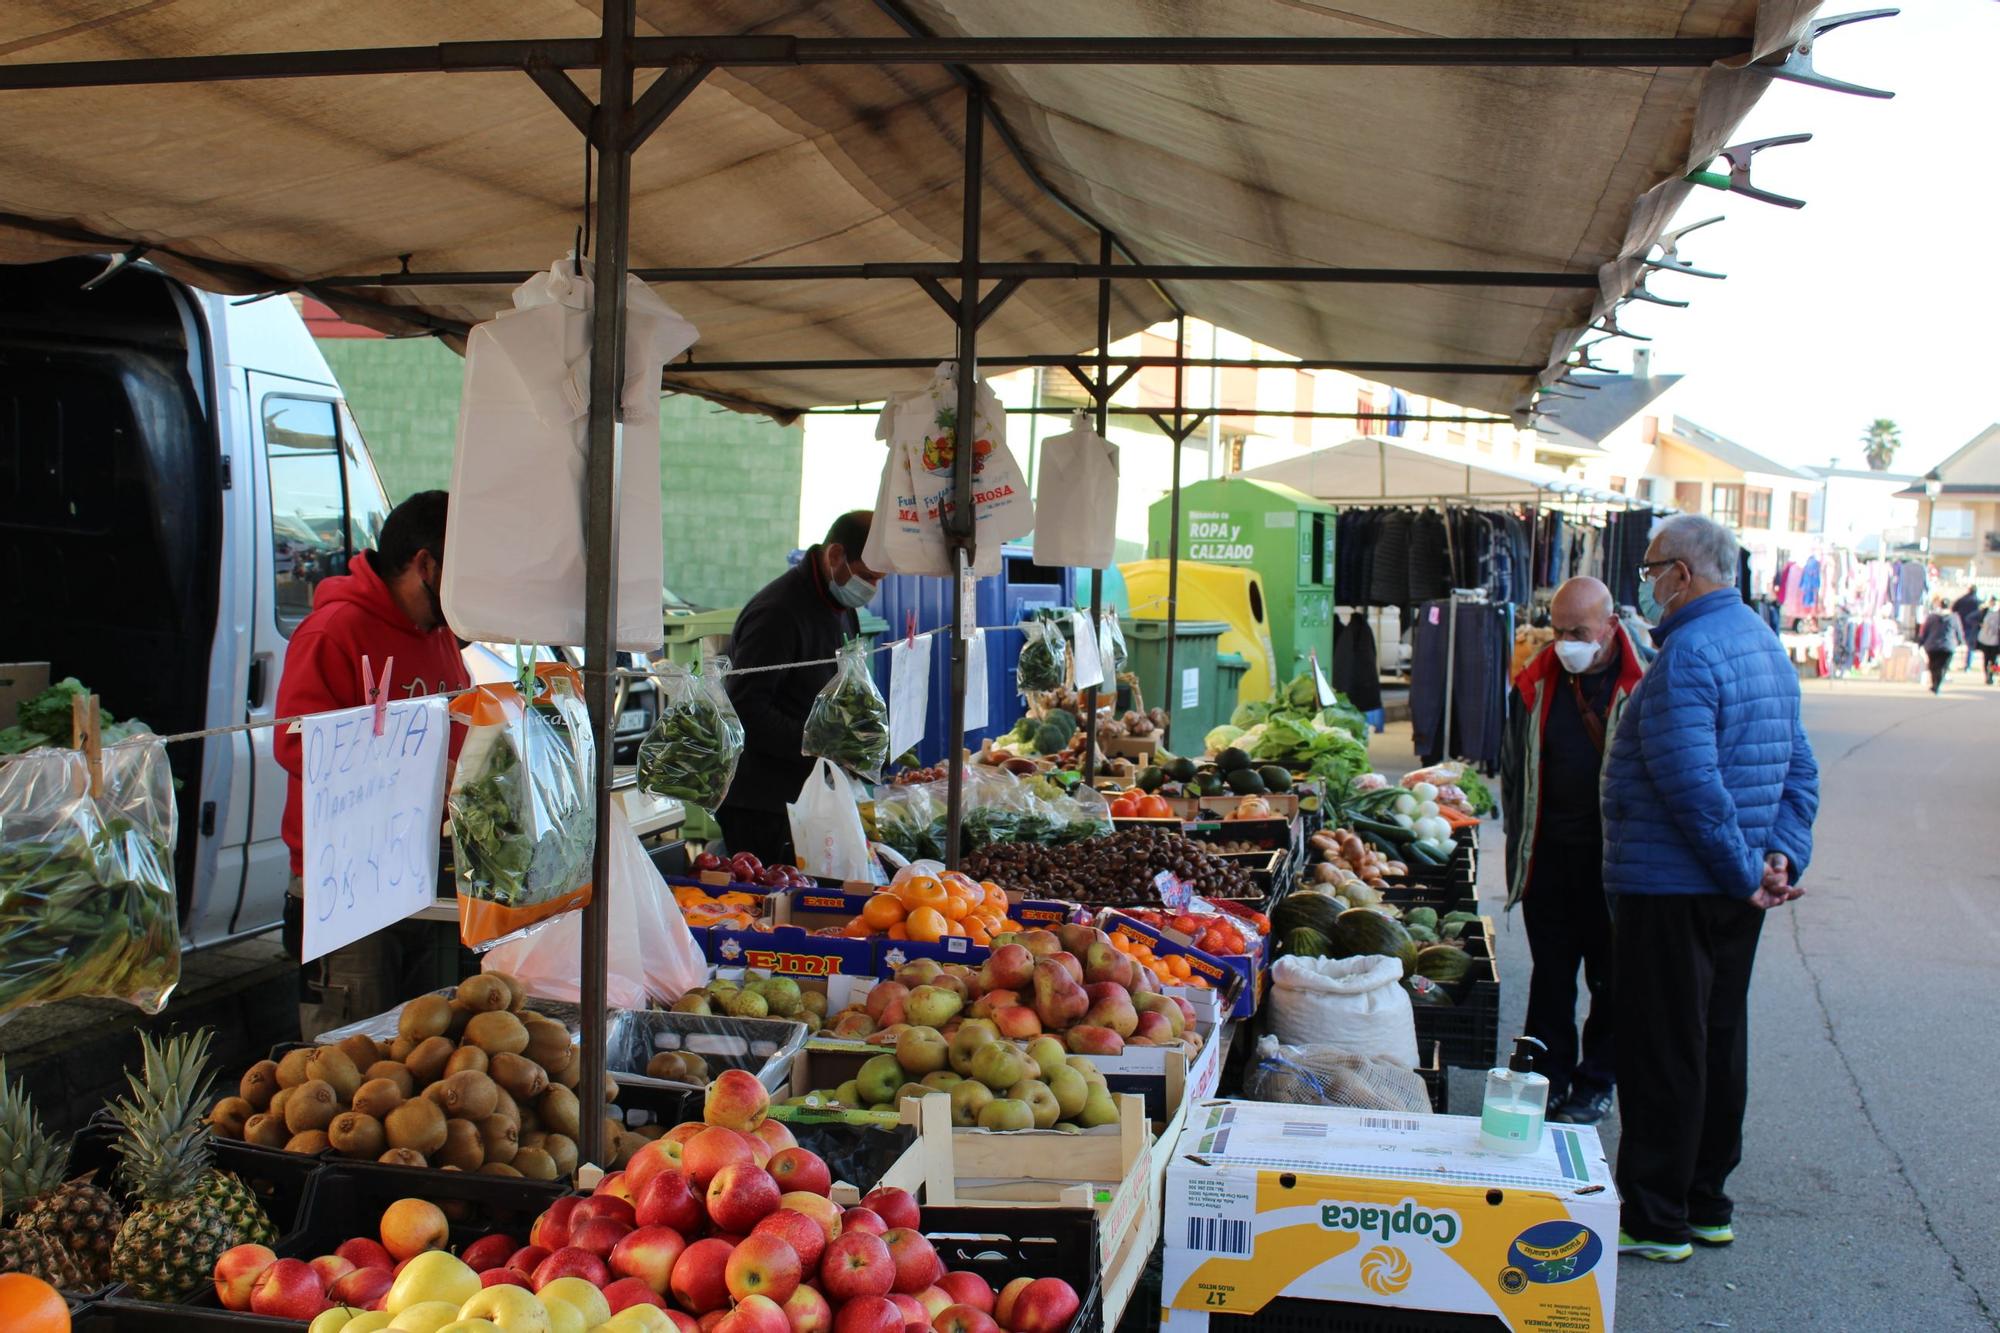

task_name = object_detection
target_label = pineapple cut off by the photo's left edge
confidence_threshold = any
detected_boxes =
[0,1061,124,1291]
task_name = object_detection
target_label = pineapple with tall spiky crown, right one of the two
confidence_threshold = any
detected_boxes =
[112,1031,278,1301]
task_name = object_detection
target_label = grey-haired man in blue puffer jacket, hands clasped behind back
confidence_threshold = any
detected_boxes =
[1602,514,1820,1261]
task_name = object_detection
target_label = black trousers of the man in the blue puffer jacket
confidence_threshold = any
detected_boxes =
[1612,893,1764,1245]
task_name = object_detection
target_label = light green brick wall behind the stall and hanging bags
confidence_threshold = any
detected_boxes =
[318,338,806,606]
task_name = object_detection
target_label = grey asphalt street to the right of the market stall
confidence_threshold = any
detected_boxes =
[1400,677,2000,1333]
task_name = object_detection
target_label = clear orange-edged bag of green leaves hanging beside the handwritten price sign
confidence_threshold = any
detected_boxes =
[444,662,596,949]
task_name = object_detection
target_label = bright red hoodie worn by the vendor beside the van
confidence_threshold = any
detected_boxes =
[272,552,472,875]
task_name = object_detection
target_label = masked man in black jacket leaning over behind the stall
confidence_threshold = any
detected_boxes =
[716,508,882,863]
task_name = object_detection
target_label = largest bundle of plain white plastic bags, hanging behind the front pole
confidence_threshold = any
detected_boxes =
[438,260,696,652]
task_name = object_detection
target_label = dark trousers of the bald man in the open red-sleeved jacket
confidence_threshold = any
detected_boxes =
[1520,841,1616,1107]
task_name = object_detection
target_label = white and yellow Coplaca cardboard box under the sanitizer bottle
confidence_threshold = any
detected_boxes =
[1160,1101,1618,1333]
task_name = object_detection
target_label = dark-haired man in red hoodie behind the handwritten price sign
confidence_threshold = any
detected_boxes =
[272,490,472,1041]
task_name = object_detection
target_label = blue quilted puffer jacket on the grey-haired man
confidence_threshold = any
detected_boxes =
[1602,588,1820,899]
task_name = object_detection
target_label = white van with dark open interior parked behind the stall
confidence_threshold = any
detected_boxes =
[0,258,406,947]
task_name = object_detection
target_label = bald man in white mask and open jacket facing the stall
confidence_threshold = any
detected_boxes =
[1500,578,1640,1125]
